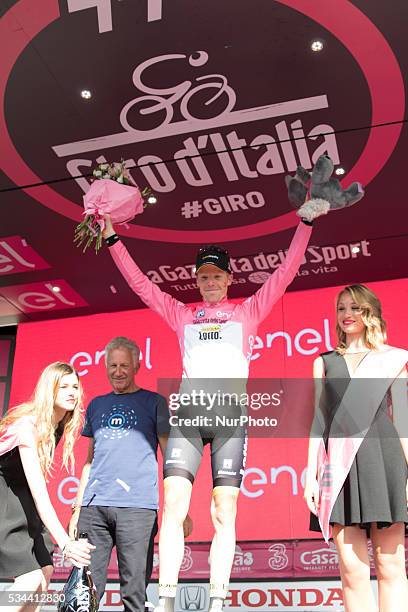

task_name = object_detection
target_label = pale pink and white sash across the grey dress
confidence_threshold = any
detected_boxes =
[317,347,408,542]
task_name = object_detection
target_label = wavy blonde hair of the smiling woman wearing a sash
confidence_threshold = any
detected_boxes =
[336,285,387,353]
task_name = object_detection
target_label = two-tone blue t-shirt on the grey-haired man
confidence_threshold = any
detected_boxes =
[82,389,169,510]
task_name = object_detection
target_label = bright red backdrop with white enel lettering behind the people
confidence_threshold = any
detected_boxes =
[11,279,408,541]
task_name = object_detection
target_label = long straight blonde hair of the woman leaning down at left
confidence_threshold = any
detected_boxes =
[0,361,83,478]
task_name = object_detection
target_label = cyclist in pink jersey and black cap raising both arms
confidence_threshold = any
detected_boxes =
[104,205,328,612]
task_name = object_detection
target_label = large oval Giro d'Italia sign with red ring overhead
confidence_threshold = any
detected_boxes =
[0,0,404,244]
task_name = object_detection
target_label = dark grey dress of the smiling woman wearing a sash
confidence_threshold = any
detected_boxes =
[309,351,408,531]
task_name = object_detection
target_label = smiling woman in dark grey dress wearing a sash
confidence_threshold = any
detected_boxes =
[304,285,408,612]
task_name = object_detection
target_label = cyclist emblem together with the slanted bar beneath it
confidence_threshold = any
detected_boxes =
[52,51,328,158]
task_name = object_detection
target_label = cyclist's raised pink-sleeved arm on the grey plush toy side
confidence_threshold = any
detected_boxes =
[242,221,312,323]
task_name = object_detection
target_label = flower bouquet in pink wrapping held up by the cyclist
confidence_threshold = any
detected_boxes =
[74,160,156,252]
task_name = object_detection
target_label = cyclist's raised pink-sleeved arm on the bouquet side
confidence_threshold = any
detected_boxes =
[103,215,184,329]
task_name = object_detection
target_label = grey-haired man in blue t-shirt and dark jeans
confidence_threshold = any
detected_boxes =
[69,337,169,612]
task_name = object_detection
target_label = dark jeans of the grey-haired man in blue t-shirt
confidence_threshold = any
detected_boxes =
[78,506,157,612]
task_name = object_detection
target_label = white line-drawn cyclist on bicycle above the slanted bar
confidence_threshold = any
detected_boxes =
[120,51,237,132]
